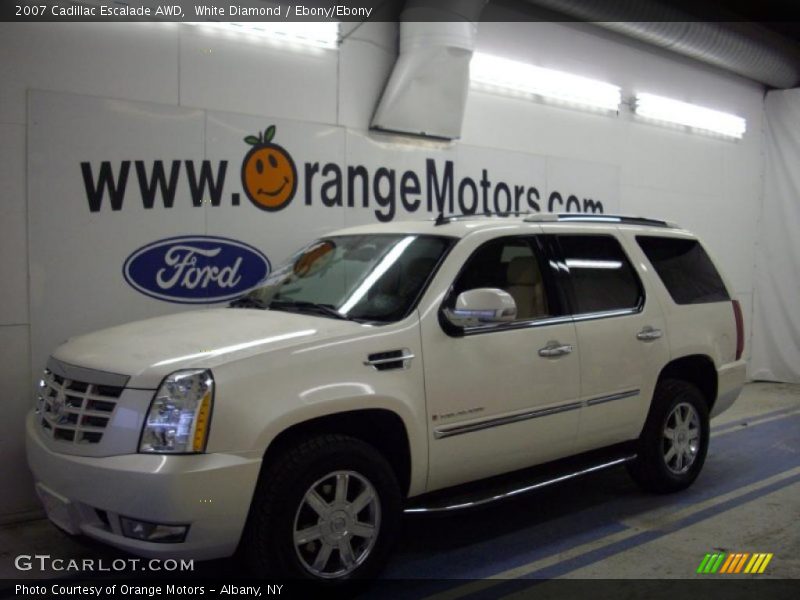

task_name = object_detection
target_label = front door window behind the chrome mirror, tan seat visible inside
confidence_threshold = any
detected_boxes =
[451,237,550,321]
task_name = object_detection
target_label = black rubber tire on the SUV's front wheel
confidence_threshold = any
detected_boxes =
[241,434,402,583]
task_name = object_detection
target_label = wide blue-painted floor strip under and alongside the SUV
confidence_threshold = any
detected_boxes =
[372,409,800,598]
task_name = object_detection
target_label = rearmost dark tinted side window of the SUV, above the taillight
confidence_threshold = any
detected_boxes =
[636,236,730,304]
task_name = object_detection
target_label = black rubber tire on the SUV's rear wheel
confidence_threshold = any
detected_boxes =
[628,379,709,494]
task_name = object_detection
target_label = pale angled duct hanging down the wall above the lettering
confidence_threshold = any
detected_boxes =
[371,0,486,139]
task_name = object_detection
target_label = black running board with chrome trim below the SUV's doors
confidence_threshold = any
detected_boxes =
[403,444,636,514]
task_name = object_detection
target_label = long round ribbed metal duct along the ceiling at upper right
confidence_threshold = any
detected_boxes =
[527,0,800,88]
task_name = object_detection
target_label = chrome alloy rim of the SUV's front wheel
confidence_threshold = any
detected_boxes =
[293,471,381,579]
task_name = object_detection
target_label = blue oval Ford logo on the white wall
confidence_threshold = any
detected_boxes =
[122,235,270,304]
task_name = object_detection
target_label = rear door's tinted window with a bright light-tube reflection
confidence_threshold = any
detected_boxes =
[558,235,643,313]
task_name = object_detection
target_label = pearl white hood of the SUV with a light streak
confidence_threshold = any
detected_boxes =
[53,308,365,389]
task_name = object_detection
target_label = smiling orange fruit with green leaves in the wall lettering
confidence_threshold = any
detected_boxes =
[242,125,297,211]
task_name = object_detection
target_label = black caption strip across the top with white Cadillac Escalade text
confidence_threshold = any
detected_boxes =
[0,0,800,22]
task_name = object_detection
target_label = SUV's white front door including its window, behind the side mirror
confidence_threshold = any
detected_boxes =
[421,236,580,490]
